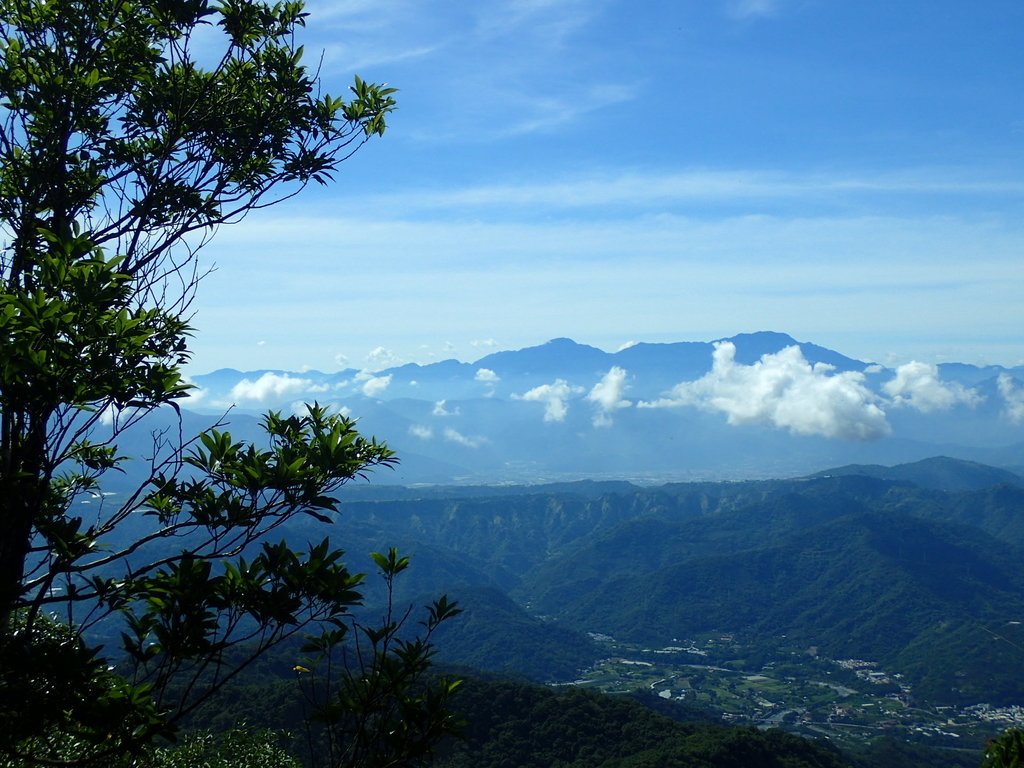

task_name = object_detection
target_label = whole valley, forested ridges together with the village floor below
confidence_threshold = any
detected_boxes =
[74,450,1024,768]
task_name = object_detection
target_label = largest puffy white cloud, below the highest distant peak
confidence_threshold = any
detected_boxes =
[639,342,889,440]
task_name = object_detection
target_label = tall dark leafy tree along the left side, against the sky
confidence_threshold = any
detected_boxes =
[0,0,458,762]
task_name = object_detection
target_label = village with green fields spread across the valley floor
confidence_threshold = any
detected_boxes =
[571,633,1024,749]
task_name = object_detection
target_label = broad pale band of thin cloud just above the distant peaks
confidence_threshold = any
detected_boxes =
[196,203,1024,370]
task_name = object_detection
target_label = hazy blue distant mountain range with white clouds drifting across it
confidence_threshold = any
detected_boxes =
[183,332,1024,483]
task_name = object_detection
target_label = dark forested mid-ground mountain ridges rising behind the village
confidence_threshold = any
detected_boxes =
[268,458,1024,705]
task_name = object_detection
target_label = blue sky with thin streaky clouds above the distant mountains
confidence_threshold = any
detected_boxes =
[193,0,1024,373]
